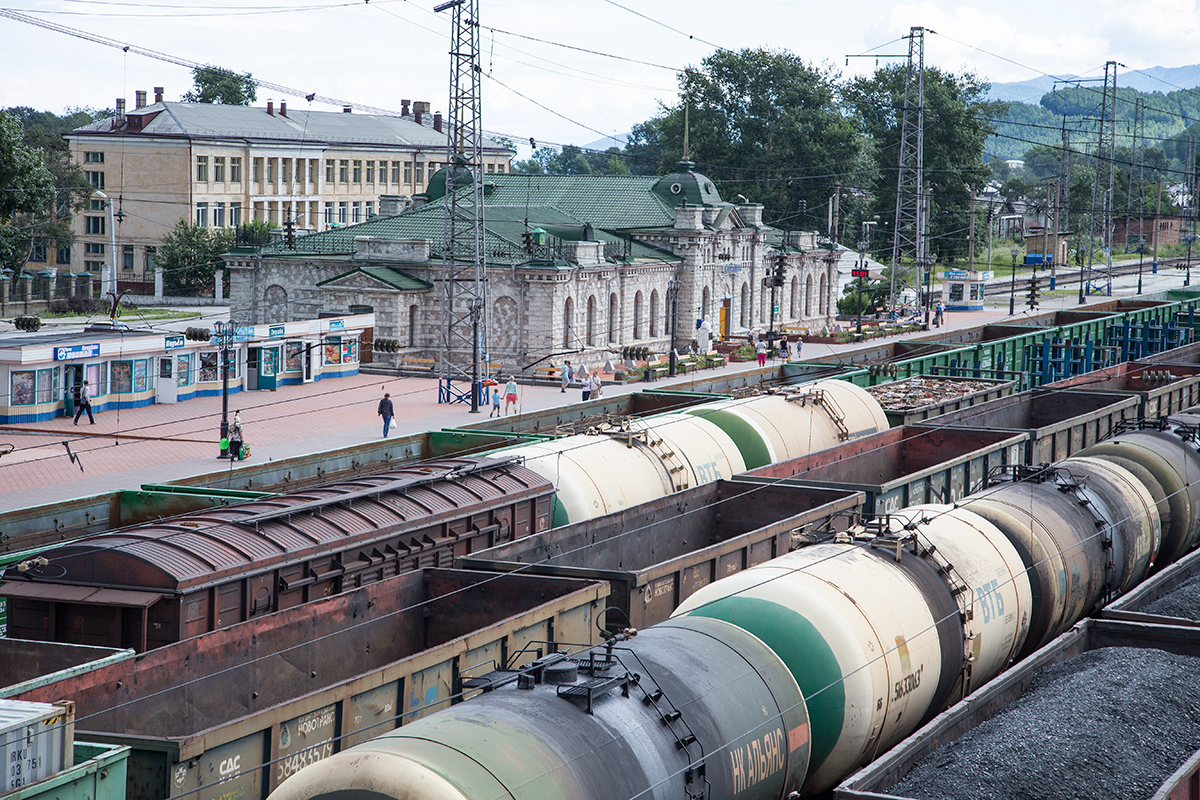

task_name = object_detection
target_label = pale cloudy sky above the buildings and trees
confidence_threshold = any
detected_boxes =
[0,0,1200,158]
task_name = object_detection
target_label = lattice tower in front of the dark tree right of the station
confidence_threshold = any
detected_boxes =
[888,28,929,309]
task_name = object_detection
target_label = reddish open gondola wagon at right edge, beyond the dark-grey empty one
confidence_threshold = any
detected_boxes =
[1043,360,1200,420]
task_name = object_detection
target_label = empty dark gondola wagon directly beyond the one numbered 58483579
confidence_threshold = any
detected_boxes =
[457,481,863,630]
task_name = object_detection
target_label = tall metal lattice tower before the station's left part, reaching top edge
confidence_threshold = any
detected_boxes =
[433,0,488,411]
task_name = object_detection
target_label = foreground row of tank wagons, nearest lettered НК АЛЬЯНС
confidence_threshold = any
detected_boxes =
[271,429,1200,800]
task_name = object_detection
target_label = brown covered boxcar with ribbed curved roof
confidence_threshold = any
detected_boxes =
[0,458,553,652]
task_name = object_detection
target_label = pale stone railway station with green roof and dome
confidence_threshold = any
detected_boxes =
[226,162,839,369]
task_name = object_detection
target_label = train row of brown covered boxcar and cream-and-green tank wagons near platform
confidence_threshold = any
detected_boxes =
[0,380,888,652]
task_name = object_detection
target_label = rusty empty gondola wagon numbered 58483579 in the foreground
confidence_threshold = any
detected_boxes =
[11,570,608,800]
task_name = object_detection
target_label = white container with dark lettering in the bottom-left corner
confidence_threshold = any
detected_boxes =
[0,699,74,794]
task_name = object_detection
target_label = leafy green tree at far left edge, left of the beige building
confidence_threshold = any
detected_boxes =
[0,112,55,271]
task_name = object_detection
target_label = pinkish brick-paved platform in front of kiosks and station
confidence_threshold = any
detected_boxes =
[0,296,1104,511]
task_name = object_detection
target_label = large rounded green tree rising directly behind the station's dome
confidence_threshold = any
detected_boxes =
[625,49,874,225]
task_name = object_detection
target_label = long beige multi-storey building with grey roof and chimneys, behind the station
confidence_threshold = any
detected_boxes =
[65,88,515,288]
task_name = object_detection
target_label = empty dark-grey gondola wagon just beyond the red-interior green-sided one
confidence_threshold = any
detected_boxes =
[912,389,1140,464]
